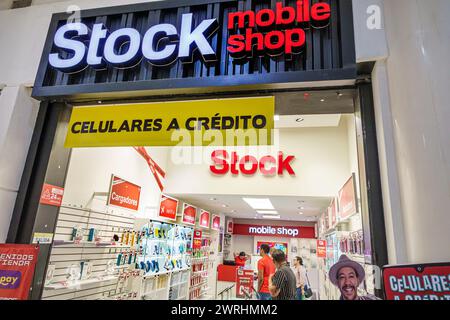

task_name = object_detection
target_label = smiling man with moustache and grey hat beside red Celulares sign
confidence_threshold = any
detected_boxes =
[329,254,380,300]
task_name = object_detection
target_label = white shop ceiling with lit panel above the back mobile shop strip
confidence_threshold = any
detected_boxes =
[170,194,331,222]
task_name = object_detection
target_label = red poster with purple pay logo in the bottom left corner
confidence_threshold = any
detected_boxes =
[0,244,39,300]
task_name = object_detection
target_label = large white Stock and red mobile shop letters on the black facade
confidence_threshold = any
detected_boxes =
[48,0,331,73]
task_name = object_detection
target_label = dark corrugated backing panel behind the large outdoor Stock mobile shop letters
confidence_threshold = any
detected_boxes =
[33,0,356,97]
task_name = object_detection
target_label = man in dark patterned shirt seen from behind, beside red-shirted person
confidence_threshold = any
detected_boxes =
[269,250,297,300]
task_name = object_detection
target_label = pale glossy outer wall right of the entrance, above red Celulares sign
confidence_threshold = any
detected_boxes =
[385,0,450,263]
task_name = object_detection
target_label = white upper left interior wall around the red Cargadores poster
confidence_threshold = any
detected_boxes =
[63,147,167,218]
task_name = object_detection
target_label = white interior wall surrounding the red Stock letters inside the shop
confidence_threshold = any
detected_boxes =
[166,121,351,197]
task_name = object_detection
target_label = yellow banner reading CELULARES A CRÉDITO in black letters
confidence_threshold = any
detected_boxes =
[65,97,275,148]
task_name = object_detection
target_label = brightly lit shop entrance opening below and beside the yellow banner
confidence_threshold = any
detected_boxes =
[25,90,384,300]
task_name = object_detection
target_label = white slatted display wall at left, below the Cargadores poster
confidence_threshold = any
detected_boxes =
[42,207,134,300]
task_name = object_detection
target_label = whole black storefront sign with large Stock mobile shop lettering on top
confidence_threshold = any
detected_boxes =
[33,0,356,99]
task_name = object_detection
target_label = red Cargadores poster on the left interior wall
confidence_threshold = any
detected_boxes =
[108,175,141,211]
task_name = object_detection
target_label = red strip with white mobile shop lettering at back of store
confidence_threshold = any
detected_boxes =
[233,224,316,239]
